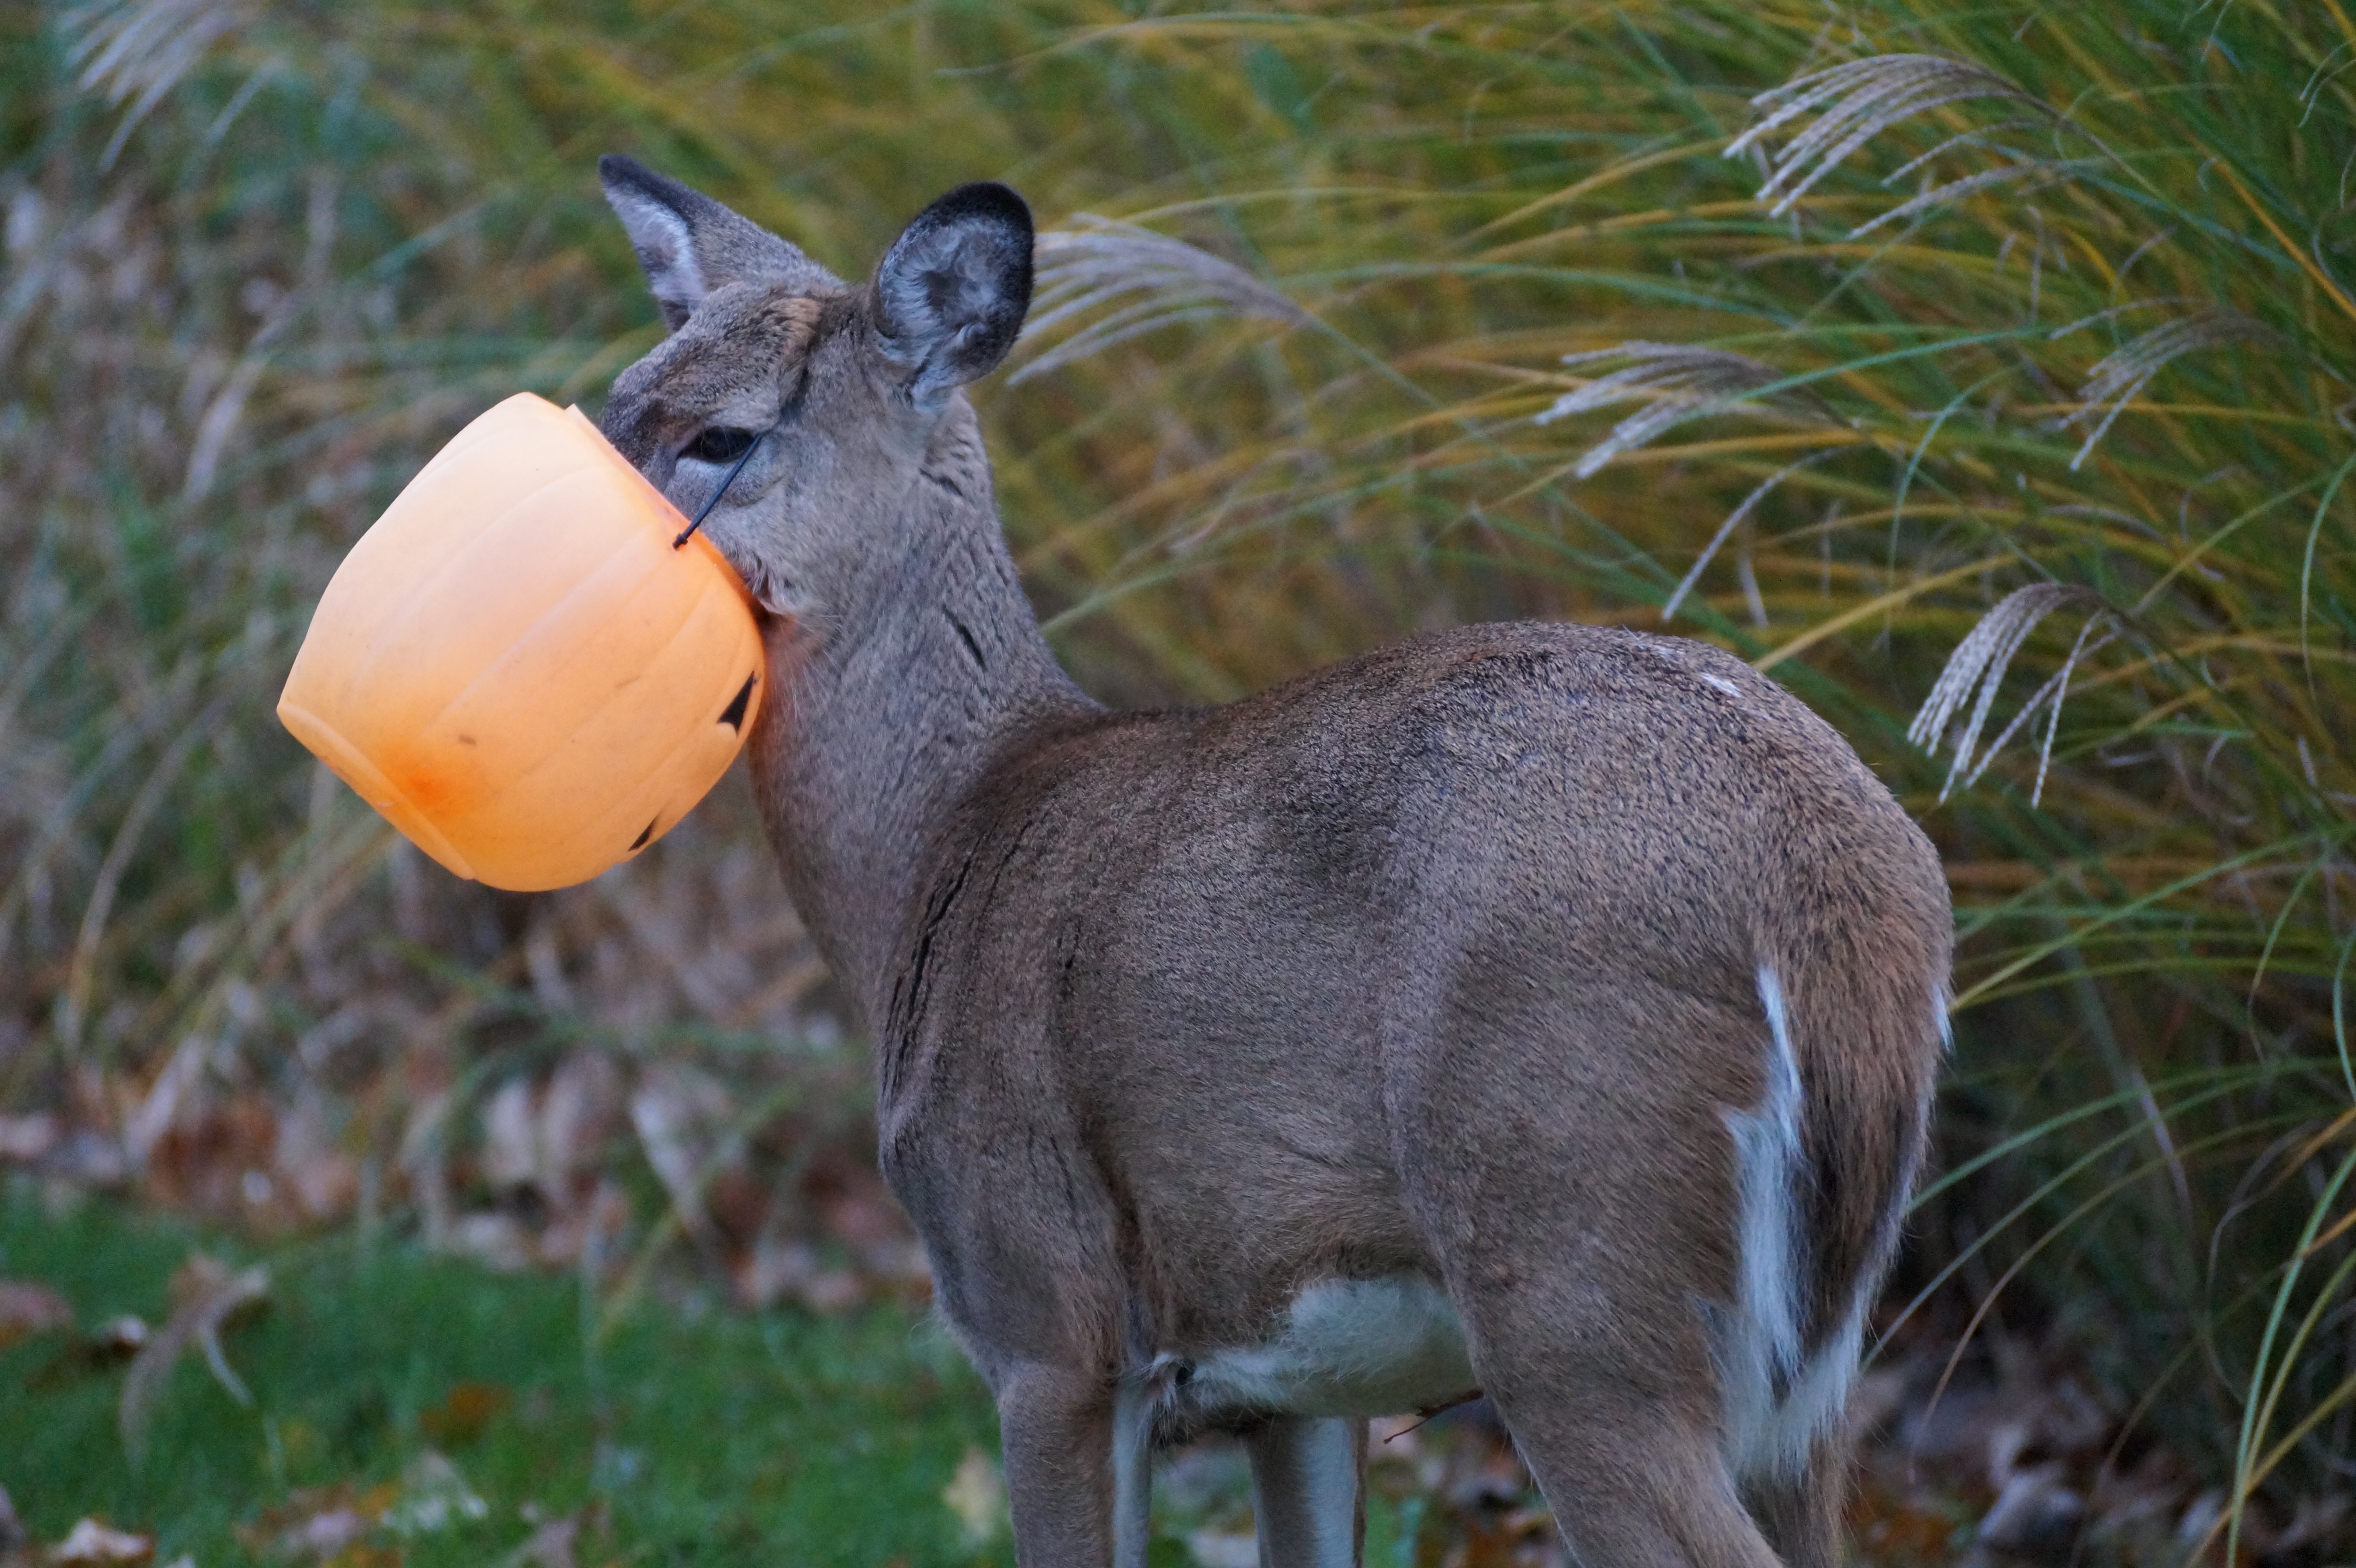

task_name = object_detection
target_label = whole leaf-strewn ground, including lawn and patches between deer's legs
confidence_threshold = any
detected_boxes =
[0,1177,2224,1568]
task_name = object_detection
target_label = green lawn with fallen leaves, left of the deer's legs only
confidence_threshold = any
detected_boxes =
[0,1177,1006,1568]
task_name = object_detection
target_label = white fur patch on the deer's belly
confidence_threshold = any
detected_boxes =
[1176,1276,1479,1415]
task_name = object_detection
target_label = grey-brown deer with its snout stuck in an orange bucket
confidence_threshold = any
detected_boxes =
[598,155,1953,1568]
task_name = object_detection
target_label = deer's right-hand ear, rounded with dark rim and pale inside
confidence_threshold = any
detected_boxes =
[874,183,1032,410]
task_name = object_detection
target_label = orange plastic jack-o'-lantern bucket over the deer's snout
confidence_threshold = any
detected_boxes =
[278,393,763,892]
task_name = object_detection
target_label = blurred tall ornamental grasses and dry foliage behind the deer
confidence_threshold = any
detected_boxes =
[14,0,2356,1561]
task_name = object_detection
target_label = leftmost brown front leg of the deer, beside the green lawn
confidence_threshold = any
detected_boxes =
[999,1363,1115,1568]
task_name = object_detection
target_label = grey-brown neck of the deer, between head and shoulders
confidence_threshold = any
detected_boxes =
[751,407,1098,1027]
